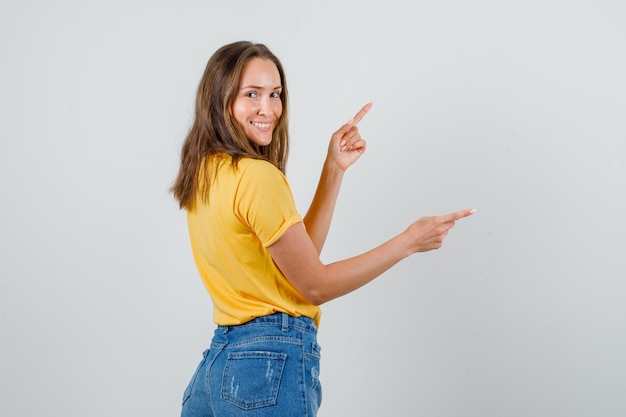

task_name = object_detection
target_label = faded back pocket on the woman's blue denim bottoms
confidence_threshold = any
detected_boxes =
[221,351,287,410]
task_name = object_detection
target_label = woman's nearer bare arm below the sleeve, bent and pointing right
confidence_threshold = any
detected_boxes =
[268,209,475,305]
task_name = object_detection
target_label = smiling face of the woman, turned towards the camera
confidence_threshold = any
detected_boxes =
[231,58,283,146]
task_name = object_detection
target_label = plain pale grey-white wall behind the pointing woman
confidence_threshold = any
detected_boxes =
[0,0,626,417]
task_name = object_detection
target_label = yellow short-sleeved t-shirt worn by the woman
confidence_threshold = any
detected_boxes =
[187,157,321,325]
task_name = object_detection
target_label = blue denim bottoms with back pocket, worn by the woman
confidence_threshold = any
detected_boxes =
[181,313,322,417]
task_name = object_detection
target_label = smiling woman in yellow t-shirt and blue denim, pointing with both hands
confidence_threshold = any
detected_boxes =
[172,42,473,417]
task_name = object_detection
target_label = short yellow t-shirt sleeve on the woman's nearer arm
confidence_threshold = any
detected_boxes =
[234,160,302,247]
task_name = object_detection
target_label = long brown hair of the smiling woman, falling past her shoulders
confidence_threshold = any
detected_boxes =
[170,41,289,209]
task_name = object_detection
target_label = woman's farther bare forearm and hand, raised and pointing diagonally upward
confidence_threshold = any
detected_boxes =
[303,103,372,254]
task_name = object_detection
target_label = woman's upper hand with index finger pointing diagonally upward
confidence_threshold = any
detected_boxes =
[327,103,372,171]
